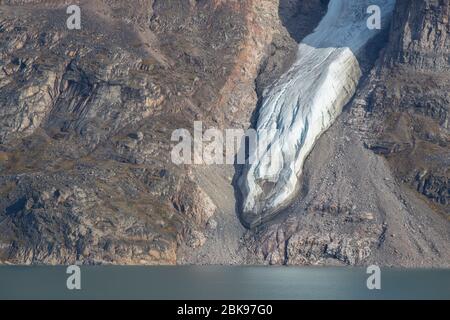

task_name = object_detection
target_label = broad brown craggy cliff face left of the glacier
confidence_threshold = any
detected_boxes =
[0,0,251,264]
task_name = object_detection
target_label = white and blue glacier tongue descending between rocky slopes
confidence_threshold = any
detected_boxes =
[239,0,395,227]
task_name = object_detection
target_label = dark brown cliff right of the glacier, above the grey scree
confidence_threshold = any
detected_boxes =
[364,1,450,212]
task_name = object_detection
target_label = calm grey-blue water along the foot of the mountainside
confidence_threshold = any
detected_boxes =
[0,266,450,299]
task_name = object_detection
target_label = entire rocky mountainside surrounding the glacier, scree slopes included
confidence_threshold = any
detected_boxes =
[0,0,450,266]
